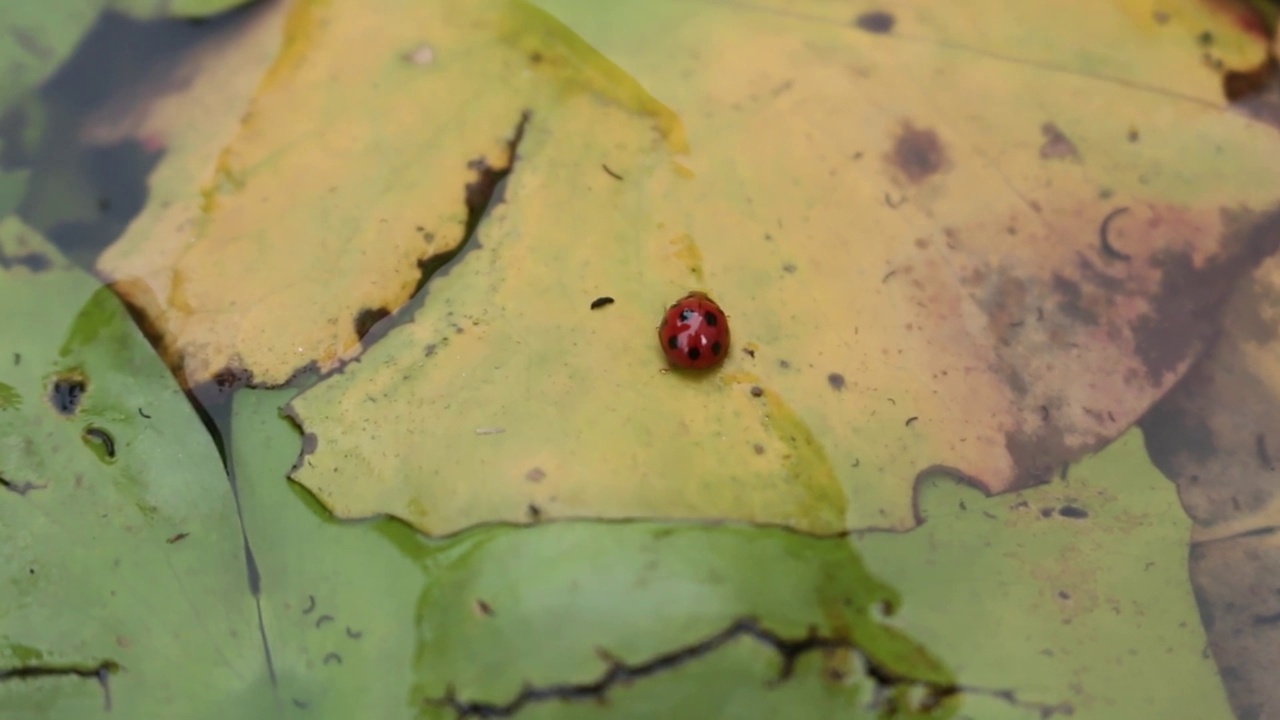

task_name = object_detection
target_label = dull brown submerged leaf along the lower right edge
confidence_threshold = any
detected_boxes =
[1143,248,1280,719]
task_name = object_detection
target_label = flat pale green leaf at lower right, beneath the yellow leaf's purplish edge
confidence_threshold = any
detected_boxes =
[856,430,1233,720]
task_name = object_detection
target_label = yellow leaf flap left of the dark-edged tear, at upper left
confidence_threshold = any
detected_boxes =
[100,0,552,384]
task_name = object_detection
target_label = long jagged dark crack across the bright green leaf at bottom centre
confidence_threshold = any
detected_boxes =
[424,618,962,719]
